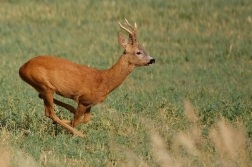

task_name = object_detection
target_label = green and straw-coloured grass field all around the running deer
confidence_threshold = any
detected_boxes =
[0,0,252,167]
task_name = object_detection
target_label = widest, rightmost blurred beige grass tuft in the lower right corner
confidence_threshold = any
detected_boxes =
[210,118,249,167]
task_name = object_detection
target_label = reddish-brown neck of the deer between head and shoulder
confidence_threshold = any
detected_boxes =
[105,55,135,92]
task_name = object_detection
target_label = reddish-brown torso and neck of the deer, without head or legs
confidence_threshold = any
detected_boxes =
[20,56,133,105]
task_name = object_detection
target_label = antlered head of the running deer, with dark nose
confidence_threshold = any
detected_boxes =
[118,19,155,66]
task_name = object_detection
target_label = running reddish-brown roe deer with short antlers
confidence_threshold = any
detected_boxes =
[19,19,155,137]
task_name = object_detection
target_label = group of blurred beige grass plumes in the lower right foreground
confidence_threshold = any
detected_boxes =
[151,101,251,167]
